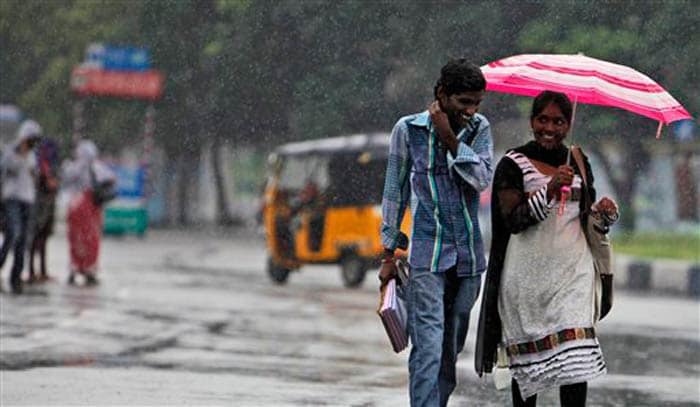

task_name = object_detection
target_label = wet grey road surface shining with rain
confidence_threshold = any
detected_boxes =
[0,228,700,406]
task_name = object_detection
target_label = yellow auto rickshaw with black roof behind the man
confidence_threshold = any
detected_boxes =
[262,133,411,287]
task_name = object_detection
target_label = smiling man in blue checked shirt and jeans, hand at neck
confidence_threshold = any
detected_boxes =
[379,59,493,406]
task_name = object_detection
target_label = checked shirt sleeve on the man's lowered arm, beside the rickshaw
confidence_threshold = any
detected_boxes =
[381,121,412,250]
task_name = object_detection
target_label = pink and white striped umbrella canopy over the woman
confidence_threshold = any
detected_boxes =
[481,54,692,138]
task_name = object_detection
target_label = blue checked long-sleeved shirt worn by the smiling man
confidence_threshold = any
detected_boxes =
[381,111,493,276]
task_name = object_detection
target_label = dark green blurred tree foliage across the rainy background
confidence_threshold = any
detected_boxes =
[0,0,700,228]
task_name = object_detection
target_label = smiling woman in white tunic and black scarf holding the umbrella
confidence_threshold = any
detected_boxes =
[476,91,618,406]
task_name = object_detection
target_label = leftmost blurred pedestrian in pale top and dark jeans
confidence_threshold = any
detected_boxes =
[0,120,41,294]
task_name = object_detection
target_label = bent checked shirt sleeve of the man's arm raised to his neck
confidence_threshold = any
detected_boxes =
[447,120,493,192]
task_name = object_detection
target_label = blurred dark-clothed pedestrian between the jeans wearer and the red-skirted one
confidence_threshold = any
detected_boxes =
[27,137,59,283]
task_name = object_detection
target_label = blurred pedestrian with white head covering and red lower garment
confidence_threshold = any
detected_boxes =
[61,140,116,286]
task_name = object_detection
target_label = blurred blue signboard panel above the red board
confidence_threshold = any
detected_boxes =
[85,44,151,71]
